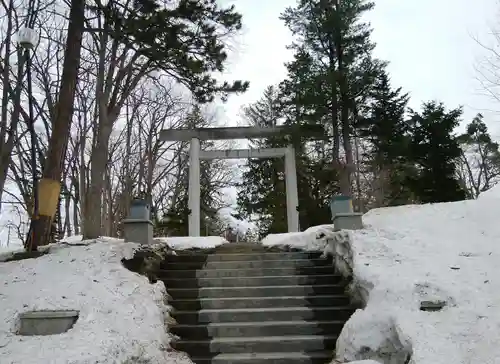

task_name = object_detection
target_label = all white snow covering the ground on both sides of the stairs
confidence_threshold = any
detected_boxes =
[0,188,500,364]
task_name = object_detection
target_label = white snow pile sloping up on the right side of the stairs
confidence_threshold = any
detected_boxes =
[263,187,500,364]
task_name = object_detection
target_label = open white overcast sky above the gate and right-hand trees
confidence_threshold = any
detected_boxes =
[217,0,500,134]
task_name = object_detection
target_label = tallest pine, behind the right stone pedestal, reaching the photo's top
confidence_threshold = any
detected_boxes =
[281,0,381,195]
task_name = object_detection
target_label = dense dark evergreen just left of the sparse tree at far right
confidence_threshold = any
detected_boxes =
[409,102,466,203]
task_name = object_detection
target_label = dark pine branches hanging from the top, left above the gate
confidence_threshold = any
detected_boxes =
[95,0,248,102]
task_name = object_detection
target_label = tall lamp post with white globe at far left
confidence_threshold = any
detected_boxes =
[17,27,39,251]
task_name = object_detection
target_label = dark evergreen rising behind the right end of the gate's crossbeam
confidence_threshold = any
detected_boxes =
[280,52,339,229]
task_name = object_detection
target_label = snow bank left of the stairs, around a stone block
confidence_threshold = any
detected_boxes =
[0,238,191,364]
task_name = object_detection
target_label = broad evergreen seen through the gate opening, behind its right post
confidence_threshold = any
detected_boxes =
[238,80,338,236]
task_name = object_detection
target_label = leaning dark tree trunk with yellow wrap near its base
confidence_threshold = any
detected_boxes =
[25,0,85,250]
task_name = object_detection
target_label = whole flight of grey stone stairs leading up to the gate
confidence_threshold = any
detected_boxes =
[158,244,354,364]
